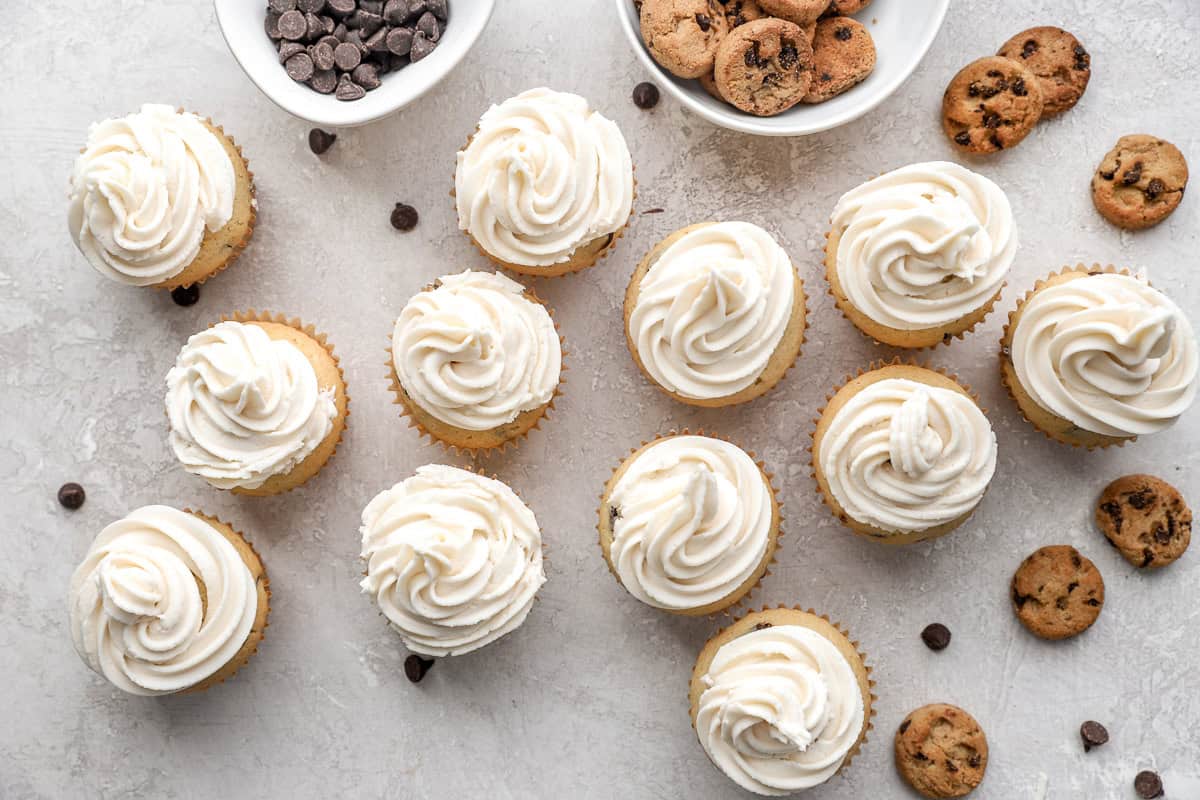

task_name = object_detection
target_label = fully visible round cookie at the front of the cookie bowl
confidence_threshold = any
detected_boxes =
[713,17,812,116]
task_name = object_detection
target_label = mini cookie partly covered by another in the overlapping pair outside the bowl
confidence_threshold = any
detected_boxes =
[997,25,1092,116]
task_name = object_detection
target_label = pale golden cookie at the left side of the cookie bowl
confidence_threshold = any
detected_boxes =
[640,0,728,78]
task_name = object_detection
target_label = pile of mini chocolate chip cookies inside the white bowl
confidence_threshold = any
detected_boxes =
[638,0,875,116]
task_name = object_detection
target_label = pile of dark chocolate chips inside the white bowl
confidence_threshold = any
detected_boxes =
[266,0,450,101]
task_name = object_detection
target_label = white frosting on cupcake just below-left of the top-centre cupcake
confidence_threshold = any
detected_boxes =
[391,270,563,431]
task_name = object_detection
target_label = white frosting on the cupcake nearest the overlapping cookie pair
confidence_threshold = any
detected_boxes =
[832,161,1016,331]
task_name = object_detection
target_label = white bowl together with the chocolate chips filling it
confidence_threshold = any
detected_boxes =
[214,0,496,127]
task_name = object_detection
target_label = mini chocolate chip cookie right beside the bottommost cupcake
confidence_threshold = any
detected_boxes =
[895,703,988,800]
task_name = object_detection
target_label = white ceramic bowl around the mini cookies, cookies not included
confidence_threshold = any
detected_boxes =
[614,0,950,136]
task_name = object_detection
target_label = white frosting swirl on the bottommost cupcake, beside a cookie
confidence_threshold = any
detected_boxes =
[696,625,865,796]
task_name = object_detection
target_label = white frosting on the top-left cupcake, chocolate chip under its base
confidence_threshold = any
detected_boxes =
[67,104,235,287]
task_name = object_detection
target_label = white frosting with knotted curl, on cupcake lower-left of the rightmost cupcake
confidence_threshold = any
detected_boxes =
[817,378,996,533]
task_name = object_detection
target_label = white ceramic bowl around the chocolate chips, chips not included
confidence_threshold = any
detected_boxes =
[214,0,496,127]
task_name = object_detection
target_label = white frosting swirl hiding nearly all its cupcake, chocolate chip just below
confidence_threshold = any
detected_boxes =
[360,464,546,656]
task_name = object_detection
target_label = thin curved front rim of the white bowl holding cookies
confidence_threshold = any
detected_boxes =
[614,0,950,137]
